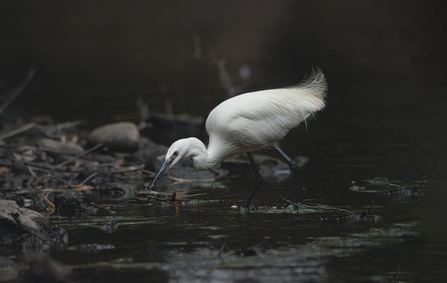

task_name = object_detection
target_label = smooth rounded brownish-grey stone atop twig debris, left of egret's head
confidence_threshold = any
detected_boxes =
[89,122,140,152]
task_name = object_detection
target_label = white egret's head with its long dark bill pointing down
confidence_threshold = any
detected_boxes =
[149,138,195,190]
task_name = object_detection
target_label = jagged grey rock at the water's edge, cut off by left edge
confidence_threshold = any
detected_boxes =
[0,200,68,251]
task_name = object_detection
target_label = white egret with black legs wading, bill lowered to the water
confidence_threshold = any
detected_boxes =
[146,68,327,210]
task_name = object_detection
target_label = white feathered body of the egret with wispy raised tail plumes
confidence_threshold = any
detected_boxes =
[206,69,327,161]
